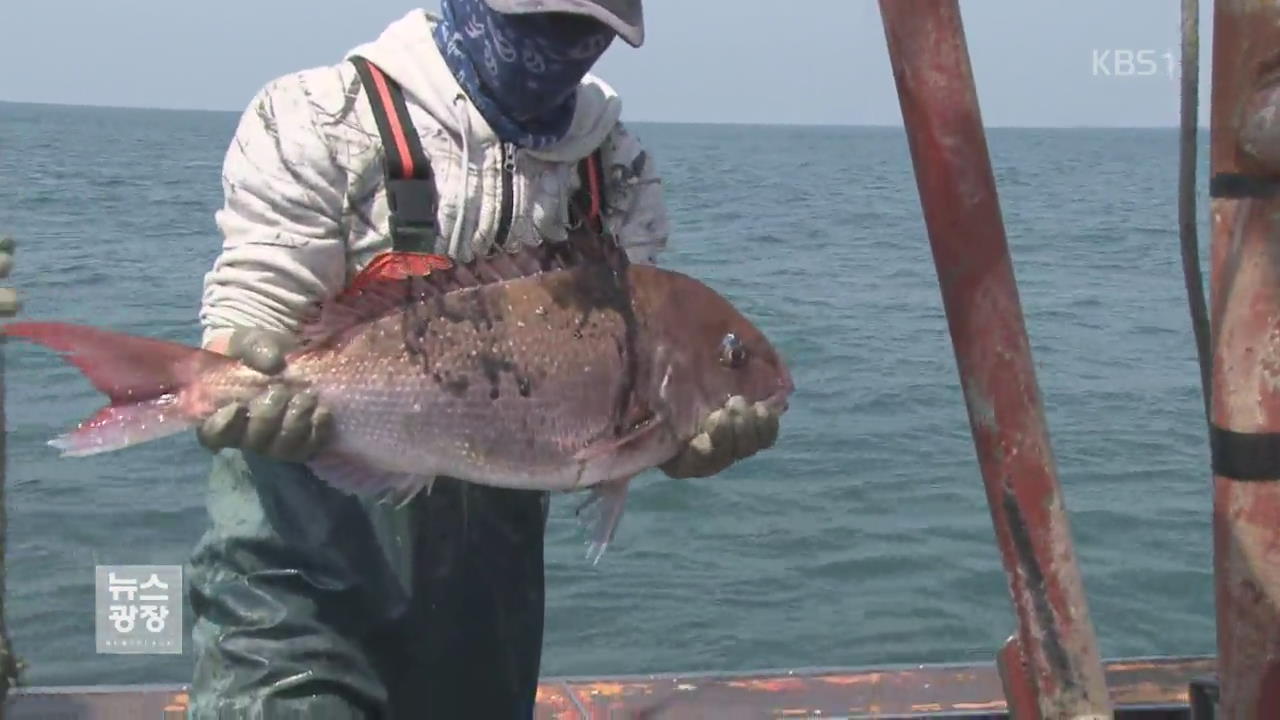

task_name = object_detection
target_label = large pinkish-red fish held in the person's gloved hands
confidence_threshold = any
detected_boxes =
[4,250,794,562]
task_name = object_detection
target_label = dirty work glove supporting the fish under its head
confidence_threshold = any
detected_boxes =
[660,395,780,478]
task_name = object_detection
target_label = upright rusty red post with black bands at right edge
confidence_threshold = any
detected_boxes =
[1210,0,1280,720]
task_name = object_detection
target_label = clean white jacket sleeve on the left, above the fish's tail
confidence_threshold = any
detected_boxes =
[200,73,347,343]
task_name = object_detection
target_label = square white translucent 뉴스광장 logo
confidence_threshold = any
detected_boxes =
[95,565,182,655]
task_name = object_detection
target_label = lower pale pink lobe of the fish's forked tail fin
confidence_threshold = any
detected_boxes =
[49,395,198,457]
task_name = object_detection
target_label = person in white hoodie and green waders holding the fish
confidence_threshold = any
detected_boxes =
[189,0,778,719]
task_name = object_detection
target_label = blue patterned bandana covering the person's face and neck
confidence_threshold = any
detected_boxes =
[434,0,614,149]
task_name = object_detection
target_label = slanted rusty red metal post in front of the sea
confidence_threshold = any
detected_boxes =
[879,0,1111,720]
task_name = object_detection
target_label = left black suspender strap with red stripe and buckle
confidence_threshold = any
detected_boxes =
[351,56,438,252]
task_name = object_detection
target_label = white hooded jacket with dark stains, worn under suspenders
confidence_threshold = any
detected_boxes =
[200,9,668,343]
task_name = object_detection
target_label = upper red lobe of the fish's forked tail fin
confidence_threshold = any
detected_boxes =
[4,323,236,406]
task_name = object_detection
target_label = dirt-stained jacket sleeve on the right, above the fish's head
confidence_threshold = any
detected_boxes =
[602,122,669,265]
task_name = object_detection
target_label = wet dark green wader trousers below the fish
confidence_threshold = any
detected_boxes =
[189,450,548,720]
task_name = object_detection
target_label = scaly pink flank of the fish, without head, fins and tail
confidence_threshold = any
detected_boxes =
[285,263,640,481]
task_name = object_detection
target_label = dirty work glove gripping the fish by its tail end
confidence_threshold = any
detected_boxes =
[196,328,333,462]
